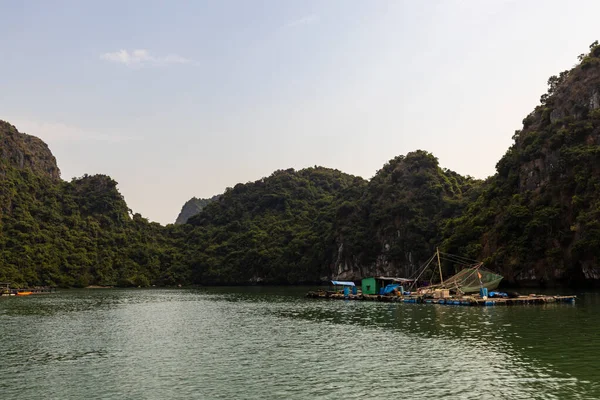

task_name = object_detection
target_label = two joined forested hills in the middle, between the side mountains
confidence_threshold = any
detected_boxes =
[177,155,480,284]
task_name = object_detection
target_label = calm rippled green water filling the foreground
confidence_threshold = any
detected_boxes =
[0,288,600,400]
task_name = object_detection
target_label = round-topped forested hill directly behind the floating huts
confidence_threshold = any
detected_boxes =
[335,150,480,276]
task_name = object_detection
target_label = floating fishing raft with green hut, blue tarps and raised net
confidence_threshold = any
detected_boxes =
[306,250,576,306]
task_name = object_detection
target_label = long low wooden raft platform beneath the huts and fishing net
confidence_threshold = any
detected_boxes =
[306,291,577,307]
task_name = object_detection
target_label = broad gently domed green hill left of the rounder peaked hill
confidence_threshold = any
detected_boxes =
[187,167,366,283]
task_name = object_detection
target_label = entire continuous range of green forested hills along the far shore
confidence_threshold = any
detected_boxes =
[0,43,600,286]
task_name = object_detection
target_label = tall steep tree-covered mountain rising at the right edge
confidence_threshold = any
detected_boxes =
[445,41,600,283]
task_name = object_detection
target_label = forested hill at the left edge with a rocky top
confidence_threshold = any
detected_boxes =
[0,121,184,286]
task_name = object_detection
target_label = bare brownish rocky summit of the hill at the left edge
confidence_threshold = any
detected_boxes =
[0,120,60,181]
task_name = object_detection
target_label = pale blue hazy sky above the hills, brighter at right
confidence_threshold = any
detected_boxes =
[0,0,600,224]
